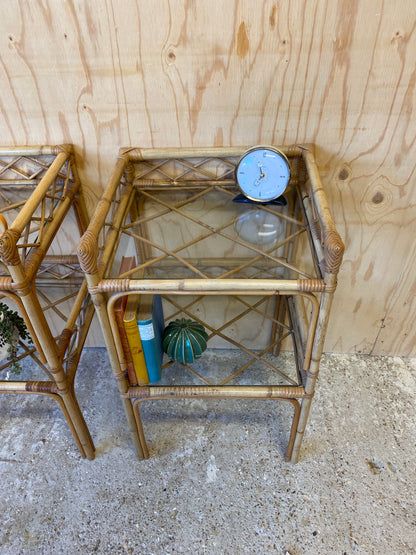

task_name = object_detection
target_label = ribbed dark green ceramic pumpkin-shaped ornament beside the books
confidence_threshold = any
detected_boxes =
[162,318,208,363]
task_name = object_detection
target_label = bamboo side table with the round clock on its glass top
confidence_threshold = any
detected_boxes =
[78,146,344,462]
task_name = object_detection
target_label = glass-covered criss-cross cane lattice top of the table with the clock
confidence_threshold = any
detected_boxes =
[98,157,319,279]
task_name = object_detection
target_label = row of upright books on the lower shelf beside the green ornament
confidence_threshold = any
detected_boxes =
[114,256,164,386]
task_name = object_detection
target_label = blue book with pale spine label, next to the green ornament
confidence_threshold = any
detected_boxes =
[137,294,165,383]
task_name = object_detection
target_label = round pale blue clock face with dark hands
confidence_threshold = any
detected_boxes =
[236,146,290,202]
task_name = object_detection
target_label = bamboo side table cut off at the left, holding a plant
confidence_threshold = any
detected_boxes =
[0,145,94,459]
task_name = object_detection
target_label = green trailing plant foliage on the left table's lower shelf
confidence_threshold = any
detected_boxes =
[0,302,32,374]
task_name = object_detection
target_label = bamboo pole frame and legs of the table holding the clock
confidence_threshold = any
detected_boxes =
[78,145,344,462]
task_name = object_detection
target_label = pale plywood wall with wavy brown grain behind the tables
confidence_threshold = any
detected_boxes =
[0,0,416,354]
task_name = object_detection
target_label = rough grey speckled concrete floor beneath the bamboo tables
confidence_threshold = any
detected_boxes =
[0,349,416,555]
